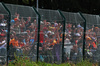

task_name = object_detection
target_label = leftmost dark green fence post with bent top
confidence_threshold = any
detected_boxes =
[2,2,11,65]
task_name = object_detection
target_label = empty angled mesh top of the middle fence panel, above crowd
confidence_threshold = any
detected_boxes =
[38,8,63,22]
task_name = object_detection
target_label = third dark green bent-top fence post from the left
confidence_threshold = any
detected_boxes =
[58,10,66,63]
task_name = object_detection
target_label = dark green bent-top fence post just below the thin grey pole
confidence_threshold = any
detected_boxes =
[33,7,41,62]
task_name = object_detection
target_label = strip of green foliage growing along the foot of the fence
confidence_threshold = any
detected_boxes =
[8,56,98,66]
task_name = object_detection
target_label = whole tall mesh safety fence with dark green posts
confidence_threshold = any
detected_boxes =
[0,3,100,64]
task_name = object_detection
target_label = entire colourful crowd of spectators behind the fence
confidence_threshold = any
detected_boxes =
[0,13,100,63]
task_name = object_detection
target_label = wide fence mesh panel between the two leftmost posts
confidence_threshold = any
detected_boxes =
[5,4,38,61]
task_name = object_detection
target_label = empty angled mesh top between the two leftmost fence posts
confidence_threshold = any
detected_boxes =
[5,4,37,17]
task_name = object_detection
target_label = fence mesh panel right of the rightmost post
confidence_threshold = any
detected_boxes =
[83,14,100,61]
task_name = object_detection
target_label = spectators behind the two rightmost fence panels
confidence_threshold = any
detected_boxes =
[65,23,100,61]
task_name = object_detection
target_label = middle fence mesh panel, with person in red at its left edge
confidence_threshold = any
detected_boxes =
[38,9,63,63]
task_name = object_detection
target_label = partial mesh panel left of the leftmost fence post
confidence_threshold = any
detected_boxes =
[0,3,9,64]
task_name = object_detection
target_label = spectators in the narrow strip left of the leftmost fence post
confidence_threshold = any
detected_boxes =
[0,14,7,63]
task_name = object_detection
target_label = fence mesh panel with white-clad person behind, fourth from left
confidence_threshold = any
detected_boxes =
[62,11,84,62]
